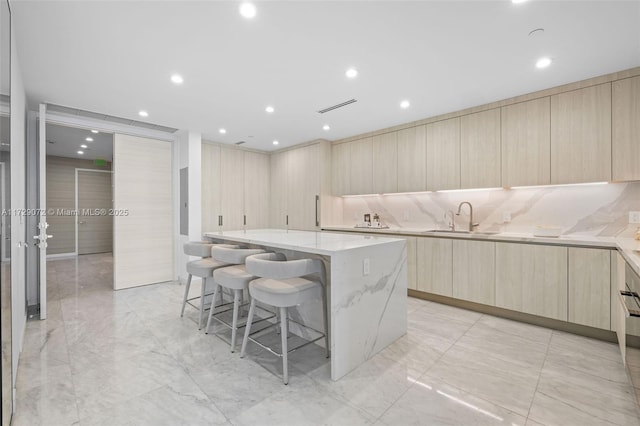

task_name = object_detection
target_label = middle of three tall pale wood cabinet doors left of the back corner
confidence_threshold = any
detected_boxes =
[220,148,244,230]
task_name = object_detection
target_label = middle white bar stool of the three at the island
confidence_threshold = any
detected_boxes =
[205,246,265,352]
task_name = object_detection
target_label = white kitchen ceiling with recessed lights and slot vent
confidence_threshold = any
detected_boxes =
[11,0,640,150]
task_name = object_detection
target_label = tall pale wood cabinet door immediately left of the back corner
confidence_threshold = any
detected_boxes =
[244,152,269,229]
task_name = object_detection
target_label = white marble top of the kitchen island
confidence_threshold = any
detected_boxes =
[204,229,402,256]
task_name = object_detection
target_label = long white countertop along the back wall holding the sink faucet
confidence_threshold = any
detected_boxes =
[322,225,640,275]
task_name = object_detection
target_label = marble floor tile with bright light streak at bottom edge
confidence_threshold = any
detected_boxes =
[380,377,525,426]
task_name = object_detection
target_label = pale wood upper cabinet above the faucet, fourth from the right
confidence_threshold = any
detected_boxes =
[460,108,501,188]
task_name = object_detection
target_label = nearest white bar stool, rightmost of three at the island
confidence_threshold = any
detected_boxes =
[240,253,329,385]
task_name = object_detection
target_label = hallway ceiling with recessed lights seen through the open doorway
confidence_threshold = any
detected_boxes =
[46,123,113,162]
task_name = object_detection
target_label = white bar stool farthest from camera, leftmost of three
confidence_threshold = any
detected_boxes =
[180,241,237,330]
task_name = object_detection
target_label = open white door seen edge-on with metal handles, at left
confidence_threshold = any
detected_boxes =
[33,104,51,320]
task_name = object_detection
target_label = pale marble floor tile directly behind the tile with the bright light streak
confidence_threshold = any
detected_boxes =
[425,345,539,416]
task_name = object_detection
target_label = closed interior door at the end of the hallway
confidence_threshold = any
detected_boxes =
[76,169,113,254]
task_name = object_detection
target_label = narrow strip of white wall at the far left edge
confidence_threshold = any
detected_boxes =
[11,19,27,387]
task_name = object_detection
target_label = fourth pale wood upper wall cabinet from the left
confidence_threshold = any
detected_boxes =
[397,125,427,192]
